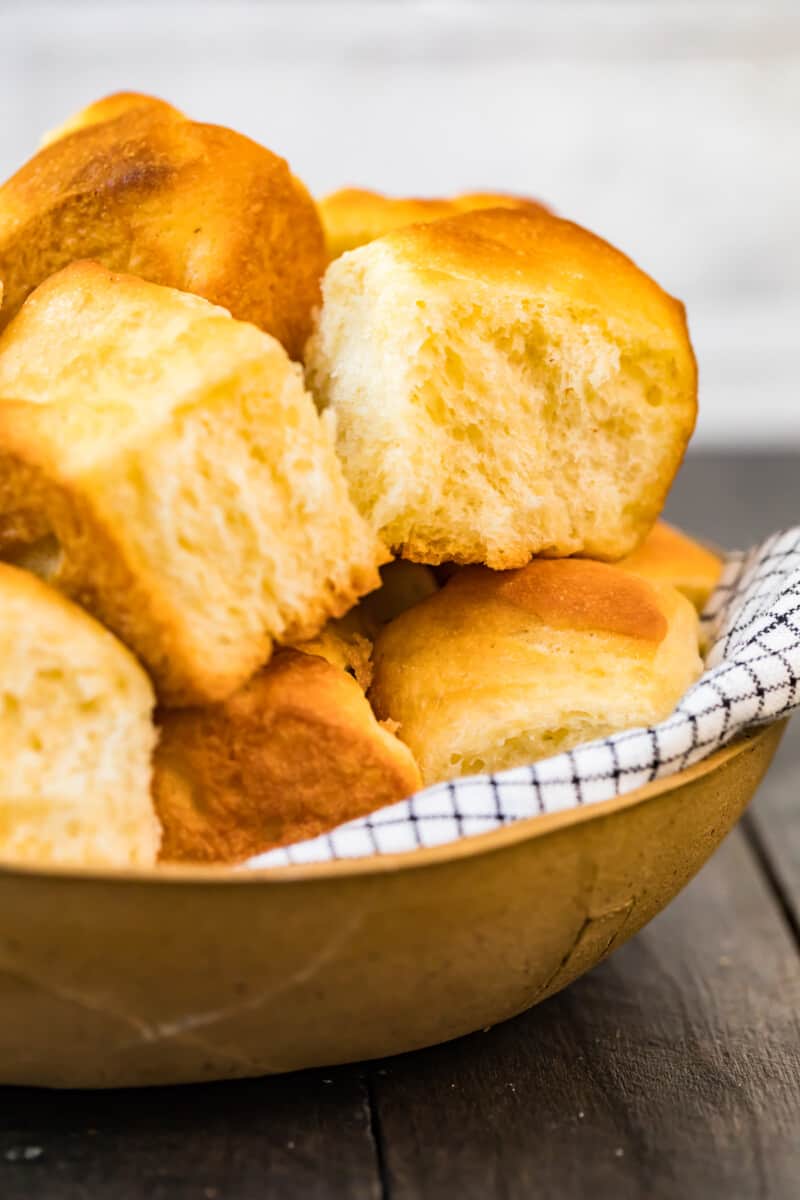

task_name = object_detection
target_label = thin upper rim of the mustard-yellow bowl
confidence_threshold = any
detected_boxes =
[0,719,787,887]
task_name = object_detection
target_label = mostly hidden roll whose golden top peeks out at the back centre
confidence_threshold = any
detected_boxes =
[317,187,547,258]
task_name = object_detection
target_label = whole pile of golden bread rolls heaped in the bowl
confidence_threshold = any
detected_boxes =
[0,94,720,866]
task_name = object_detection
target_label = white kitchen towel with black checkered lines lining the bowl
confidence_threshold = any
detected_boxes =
[246,526,800,868]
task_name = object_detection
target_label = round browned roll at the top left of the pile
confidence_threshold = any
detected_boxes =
[0,94,325,358]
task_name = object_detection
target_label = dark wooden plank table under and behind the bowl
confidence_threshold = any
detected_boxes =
[0,454,800,1200]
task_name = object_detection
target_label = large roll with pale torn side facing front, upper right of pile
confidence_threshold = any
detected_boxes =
[306,209,697,568]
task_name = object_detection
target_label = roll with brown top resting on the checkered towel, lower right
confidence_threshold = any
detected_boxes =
[371,559,702,784]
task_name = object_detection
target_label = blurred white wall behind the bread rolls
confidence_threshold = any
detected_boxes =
[0,0,800,446]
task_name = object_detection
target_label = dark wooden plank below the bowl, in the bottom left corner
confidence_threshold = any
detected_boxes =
[0,1068,380,1200]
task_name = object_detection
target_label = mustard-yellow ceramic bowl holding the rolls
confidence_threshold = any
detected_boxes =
[0,725,782,1087]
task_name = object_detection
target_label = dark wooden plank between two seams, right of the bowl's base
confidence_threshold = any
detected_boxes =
[374,830,800,1200]
